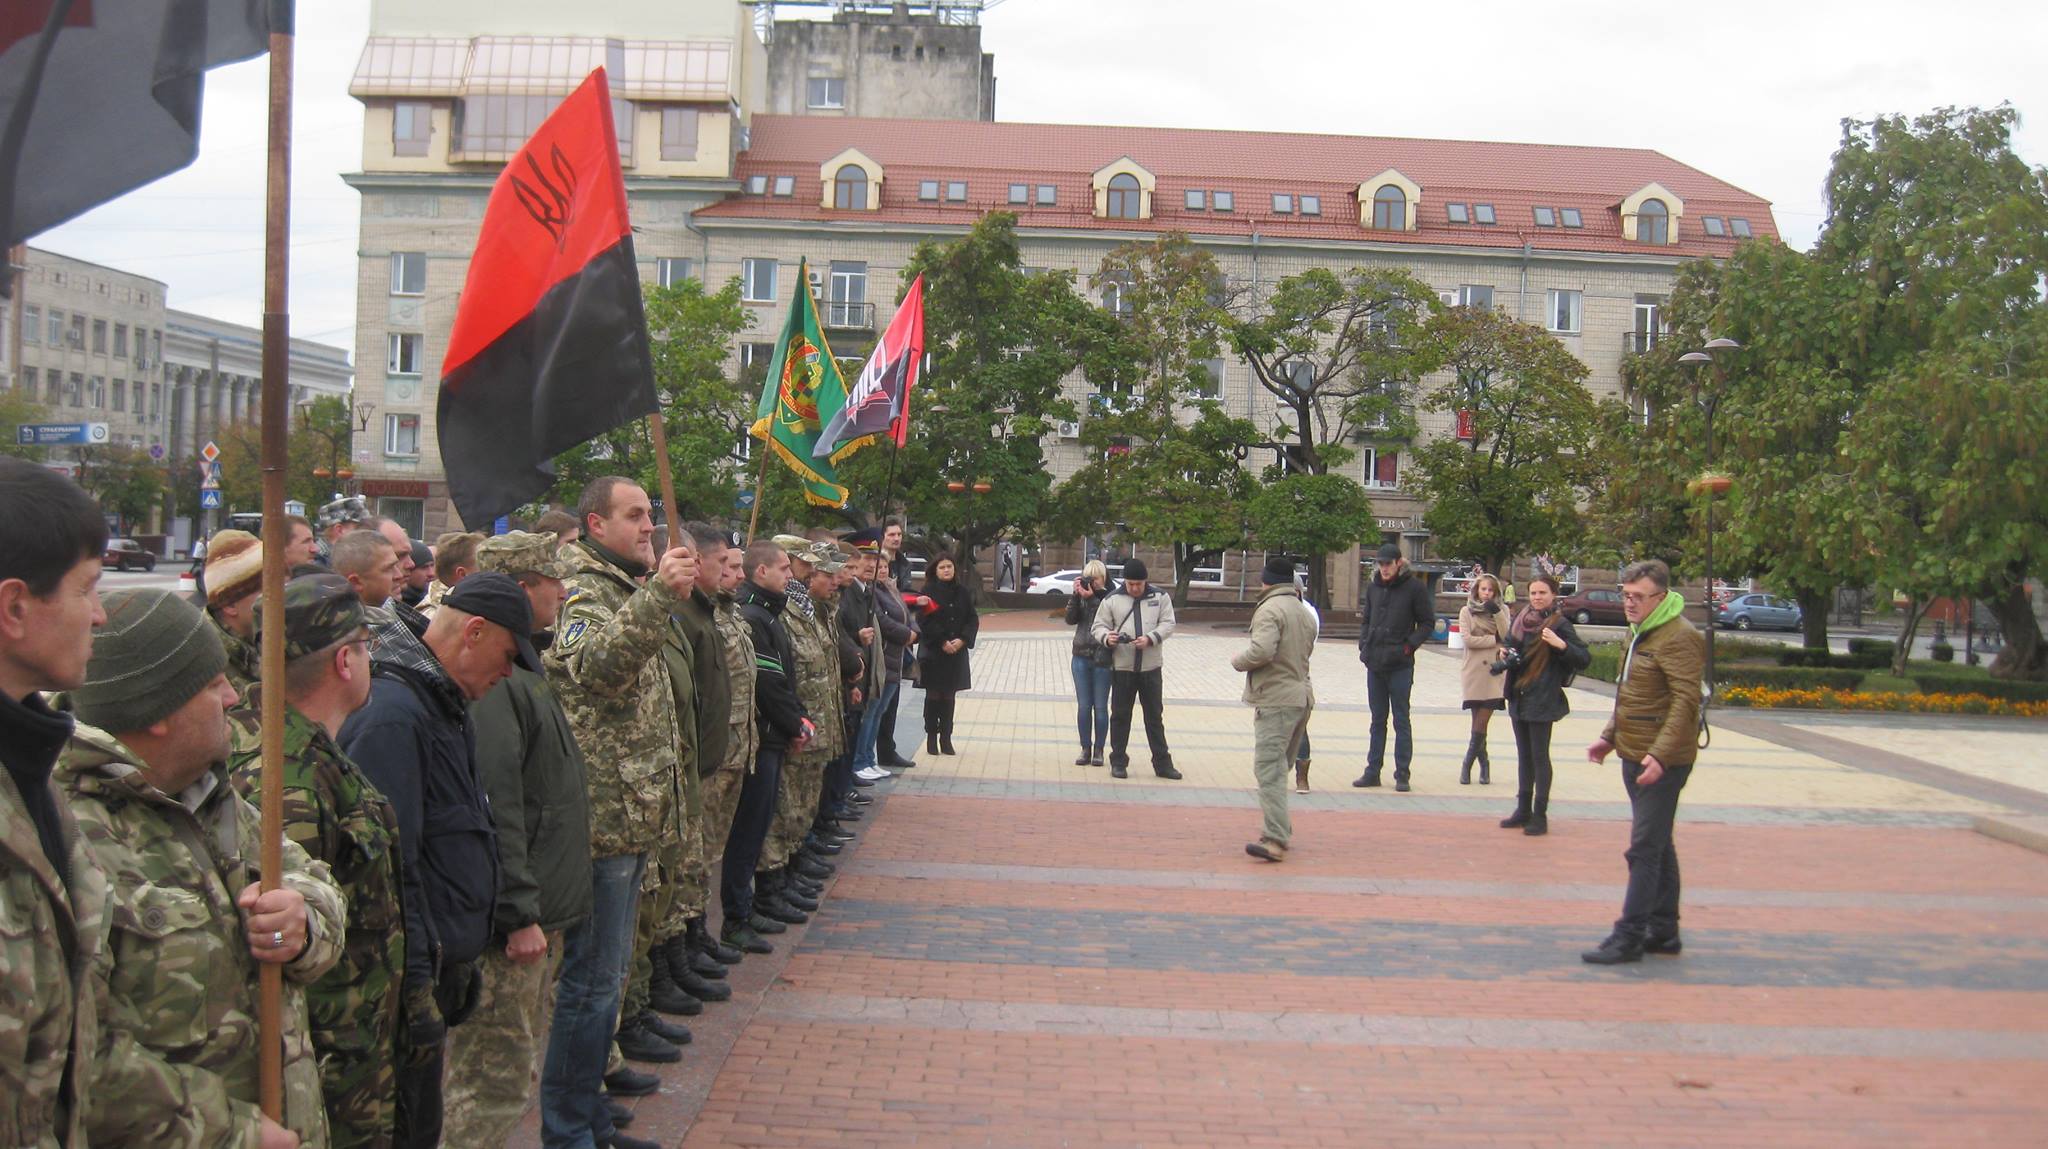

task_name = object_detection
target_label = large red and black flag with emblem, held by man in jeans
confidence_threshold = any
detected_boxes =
[438,68,655,524]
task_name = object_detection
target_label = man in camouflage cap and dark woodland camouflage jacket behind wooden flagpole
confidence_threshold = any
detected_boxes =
[229,571,406,1149]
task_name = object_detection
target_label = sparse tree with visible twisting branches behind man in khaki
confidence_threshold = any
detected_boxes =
[1231,268,1440,602]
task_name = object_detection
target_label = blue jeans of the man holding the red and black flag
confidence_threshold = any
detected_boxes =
[541,854,647,1149]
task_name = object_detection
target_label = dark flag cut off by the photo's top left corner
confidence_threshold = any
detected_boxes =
[0,0,272,259]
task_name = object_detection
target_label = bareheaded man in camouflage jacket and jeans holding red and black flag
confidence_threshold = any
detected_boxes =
[541,477,696,1145]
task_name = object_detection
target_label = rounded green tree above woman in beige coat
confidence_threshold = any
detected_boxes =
[1409,307,1606,569]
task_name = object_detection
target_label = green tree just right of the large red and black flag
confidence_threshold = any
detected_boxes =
[551,279,760,522]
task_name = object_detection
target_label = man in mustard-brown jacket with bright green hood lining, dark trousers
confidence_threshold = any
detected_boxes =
[1579,559,1706,965]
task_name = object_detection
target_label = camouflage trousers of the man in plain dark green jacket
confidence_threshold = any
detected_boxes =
[440,930,561,1147]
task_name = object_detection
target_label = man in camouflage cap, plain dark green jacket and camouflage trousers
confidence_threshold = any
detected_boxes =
[442,530,592,1145]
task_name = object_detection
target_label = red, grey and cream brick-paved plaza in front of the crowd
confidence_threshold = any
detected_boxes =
[522,614,2048,1149]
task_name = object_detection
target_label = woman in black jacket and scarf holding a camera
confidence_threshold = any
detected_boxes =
[1487,573,1593,836]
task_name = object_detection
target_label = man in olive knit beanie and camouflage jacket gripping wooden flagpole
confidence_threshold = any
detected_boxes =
[57,590,346,1149]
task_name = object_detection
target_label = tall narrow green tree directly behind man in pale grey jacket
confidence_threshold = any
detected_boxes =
[1061,231,1260,606]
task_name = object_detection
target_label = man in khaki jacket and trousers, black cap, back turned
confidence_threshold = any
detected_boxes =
[1231,559,1315,862]
